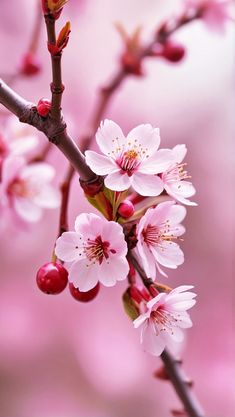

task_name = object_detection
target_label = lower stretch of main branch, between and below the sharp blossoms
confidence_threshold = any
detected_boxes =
[128,252,205,417]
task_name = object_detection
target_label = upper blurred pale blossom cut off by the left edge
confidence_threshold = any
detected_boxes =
[0,117,39,166]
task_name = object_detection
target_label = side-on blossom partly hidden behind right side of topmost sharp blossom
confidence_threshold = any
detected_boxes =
[161,145,197,206]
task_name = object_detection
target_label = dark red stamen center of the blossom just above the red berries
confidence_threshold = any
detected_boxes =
[84,236,116,265]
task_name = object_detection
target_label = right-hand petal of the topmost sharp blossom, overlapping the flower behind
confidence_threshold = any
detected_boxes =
[138,149,173,174]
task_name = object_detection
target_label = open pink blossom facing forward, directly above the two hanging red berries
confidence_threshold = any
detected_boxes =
[55,213,129,292]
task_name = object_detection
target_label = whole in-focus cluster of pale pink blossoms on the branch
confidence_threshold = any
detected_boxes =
[55,120,196,355]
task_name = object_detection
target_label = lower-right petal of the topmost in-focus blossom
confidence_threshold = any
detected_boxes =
[130,172,163,197]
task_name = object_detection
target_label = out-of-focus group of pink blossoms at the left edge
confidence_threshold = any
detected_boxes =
[0,120,60,224]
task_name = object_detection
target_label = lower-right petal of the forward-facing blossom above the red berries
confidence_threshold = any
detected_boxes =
[99,256,129,287]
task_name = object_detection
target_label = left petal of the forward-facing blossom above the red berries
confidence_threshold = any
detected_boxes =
[55,232,85,262]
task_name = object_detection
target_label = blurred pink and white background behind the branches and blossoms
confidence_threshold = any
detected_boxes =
[0,0,235,417]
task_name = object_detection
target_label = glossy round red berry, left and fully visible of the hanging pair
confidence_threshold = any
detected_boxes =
[36,262,68,294]
